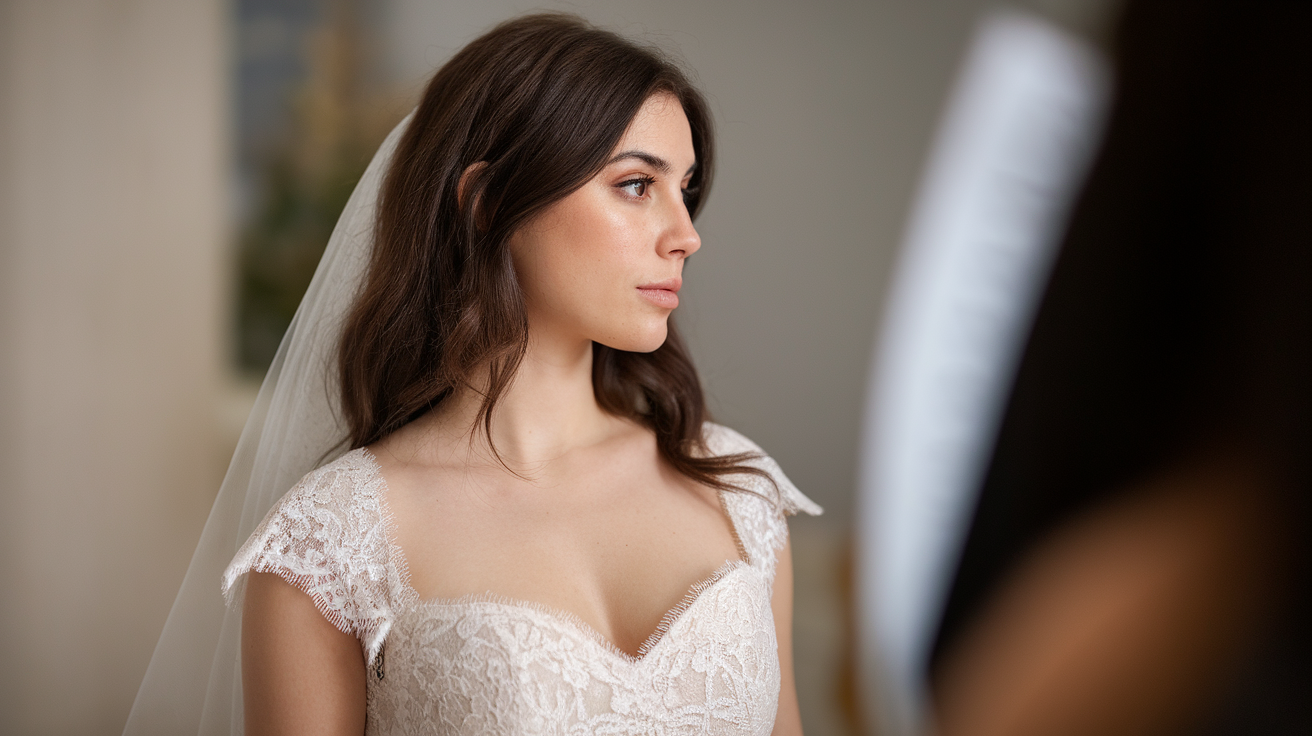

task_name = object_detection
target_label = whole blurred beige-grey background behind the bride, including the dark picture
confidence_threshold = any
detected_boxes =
[0,0,1110,736]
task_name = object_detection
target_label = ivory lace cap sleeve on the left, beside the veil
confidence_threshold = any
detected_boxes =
[223,450,404,664]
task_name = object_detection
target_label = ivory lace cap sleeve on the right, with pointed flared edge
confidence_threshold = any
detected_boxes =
[703,422,824,571]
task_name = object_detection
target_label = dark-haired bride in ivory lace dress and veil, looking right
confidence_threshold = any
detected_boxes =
[129,14,819,735]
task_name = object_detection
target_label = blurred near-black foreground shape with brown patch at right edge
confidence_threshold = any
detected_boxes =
[933,0,1312,736]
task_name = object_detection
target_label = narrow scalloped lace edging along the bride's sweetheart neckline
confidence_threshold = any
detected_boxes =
[358,447,752,665]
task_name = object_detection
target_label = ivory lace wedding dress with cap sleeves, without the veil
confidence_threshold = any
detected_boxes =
[223,424,820,735]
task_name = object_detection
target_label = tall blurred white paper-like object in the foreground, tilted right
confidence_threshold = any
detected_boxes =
[857,12,1109,733]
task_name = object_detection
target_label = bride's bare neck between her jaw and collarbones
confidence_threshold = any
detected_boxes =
[430,325,615,470]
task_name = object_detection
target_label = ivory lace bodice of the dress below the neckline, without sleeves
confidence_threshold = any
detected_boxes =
[367,564,779,735]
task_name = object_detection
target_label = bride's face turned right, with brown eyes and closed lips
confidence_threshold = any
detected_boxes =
[510,94,702,353]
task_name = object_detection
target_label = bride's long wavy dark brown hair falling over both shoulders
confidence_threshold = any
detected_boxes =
[338,14,769,489]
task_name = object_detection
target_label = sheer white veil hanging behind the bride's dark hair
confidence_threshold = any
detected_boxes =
[123,115,412,736]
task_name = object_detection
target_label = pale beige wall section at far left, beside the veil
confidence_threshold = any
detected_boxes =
[0,0,228,733]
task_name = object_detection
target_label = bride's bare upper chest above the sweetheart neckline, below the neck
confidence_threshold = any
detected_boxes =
[387,456,741,652]
